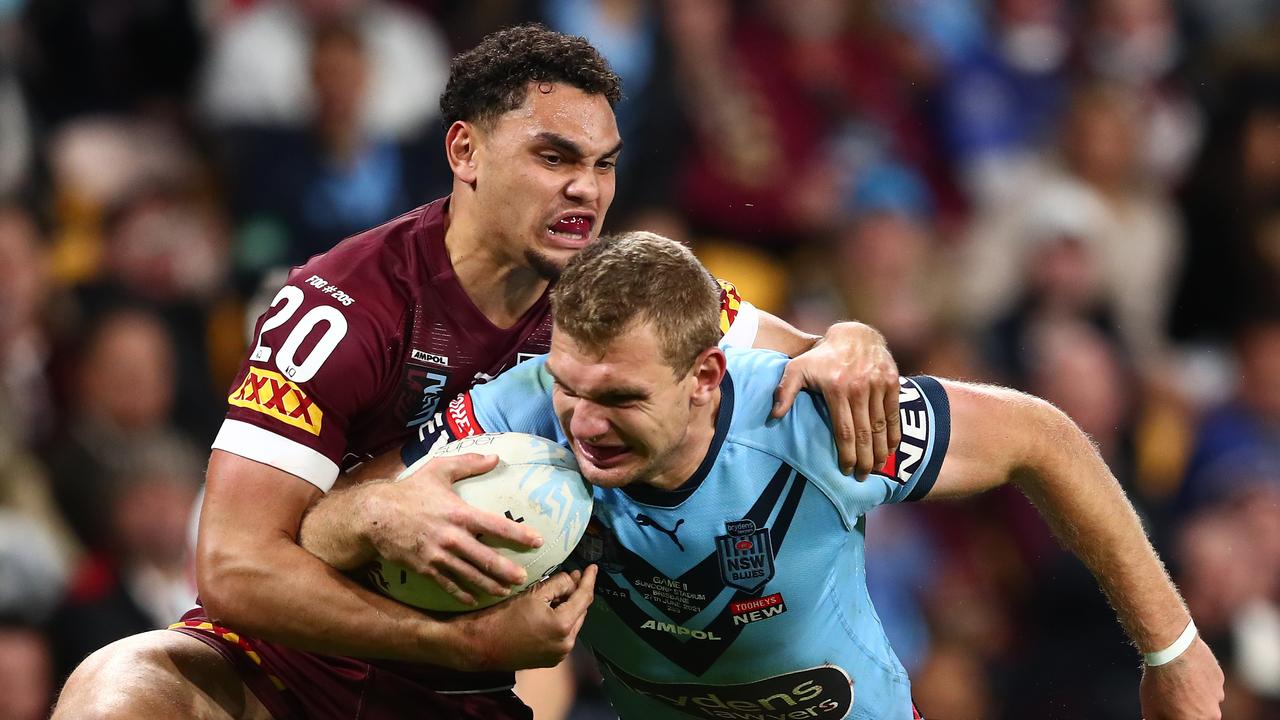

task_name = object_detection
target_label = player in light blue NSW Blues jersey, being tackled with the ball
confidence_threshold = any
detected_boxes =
[303,233,1222,720]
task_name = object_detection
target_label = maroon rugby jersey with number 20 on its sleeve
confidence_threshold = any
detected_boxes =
[214,200,550,491]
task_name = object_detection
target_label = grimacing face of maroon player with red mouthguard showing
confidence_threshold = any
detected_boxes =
[476,82,622,275]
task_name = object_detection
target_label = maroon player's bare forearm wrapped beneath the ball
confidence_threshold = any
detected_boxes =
[200,538,474,669]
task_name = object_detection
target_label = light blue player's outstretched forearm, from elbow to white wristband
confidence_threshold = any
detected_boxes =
[1012,404,1189,652]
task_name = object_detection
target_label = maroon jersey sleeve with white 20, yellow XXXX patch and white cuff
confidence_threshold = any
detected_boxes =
[212,270,402,492]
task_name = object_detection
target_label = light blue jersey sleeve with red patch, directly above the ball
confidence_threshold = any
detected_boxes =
[401,355,564,468]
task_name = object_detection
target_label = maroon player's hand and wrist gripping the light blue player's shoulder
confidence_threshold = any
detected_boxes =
[755,311,902,478]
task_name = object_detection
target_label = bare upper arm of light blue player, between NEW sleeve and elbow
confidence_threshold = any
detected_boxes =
[928,380,1055,500]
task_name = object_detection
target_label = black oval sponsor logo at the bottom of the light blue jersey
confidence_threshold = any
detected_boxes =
[598,656,854,720]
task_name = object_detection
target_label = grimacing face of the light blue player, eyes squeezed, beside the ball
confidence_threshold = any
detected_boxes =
[547,324,696,487]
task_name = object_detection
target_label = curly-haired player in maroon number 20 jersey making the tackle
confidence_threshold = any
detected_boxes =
[55,26,899,720]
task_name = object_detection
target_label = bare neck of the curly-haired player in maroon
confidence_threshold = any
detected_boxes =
[444,202,549,328]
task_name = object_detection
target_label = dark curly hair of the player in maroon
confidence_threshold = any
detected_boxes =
[440,23,622,128]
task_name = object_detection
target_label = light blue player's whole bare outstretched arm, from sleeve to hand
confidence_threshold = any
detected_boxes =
[928,380,1222,720]
